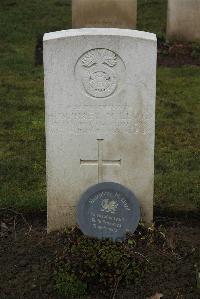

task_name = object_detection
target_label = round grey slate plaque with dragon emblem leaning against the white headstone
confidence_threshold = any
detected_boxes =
[77,182,140,241]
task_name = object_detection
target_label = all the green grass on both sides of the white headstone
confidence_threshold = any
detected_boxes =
[0,0,200,216]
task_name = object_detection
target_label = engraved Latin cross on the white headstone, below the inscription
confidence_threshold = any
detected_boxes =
[80,139,121,183]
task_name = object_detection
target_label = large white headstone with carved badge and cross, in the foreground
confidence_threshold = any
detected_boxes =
[44,29,157,231]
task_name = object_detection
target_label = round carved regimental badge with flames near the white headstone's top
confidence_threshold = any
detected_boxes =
[76,49,125,98]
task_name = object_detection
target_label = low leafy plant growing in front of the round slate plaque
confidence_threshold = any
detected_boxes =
[56,225,165,296]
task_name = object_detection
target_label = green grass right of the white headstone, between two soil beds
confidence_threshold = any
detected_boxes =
[155,67,200,212]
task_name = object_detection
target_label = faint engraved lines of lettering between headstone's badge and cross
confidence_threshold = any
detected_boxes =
[47,106,153,134]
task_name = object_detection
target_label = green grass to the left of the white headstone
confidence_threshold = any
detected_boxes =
[0,0,71,211]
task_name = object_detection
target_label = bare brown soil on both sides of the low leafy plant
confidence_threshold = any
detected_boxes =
[0,211,200,299]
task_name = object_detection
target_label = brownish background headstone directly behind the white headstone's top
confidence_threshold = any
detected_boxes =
[72,0,137,29]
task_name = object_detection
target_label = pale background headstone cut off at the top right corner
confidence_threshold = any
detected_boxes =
[167,0,200,41]
